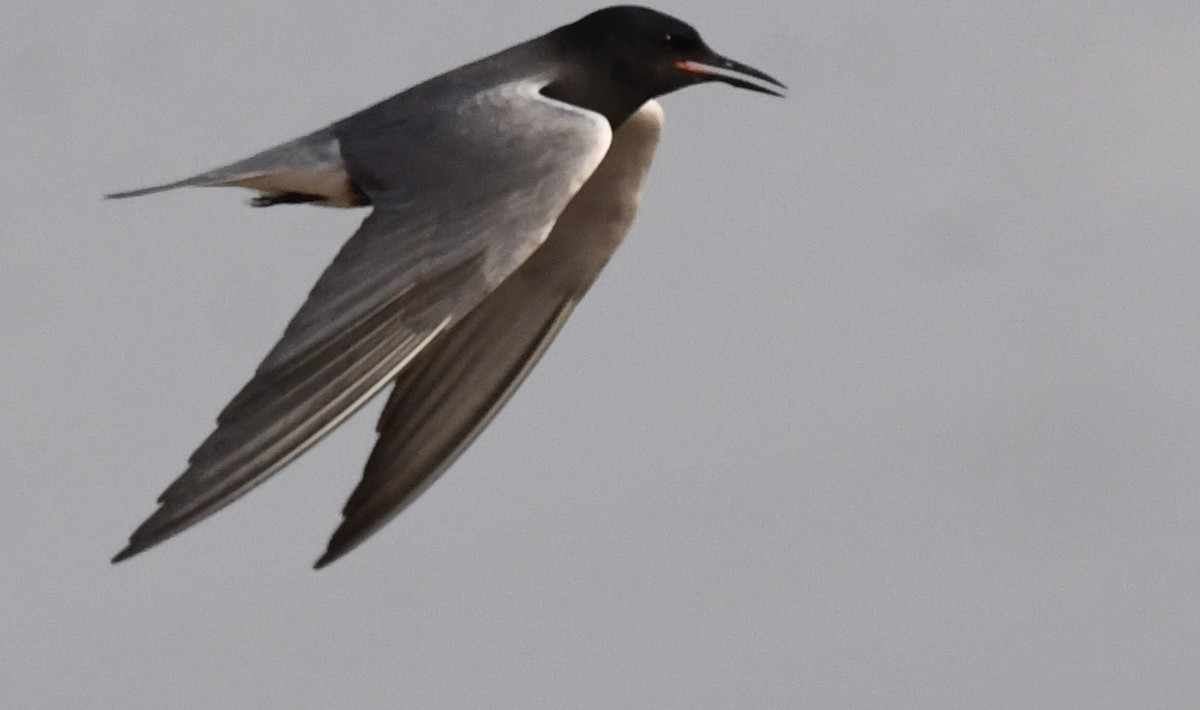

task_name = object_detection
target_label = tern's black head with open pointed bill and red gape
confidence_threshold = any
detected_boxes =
[544,5,785,127]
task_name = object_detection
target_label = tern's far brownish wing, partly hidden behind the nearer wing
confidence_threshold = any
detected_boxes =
[317,101,662,567]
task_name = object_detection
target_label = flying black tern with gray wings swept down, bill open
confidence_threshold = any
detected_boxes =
[108,6,785,567]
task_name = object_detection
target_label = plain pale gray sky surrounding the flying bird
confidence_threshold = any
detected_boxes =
[0,0,1200,709]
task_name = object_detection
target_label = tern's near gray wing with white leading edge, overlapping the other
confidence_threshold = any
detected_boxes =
[114,83,611,561]
